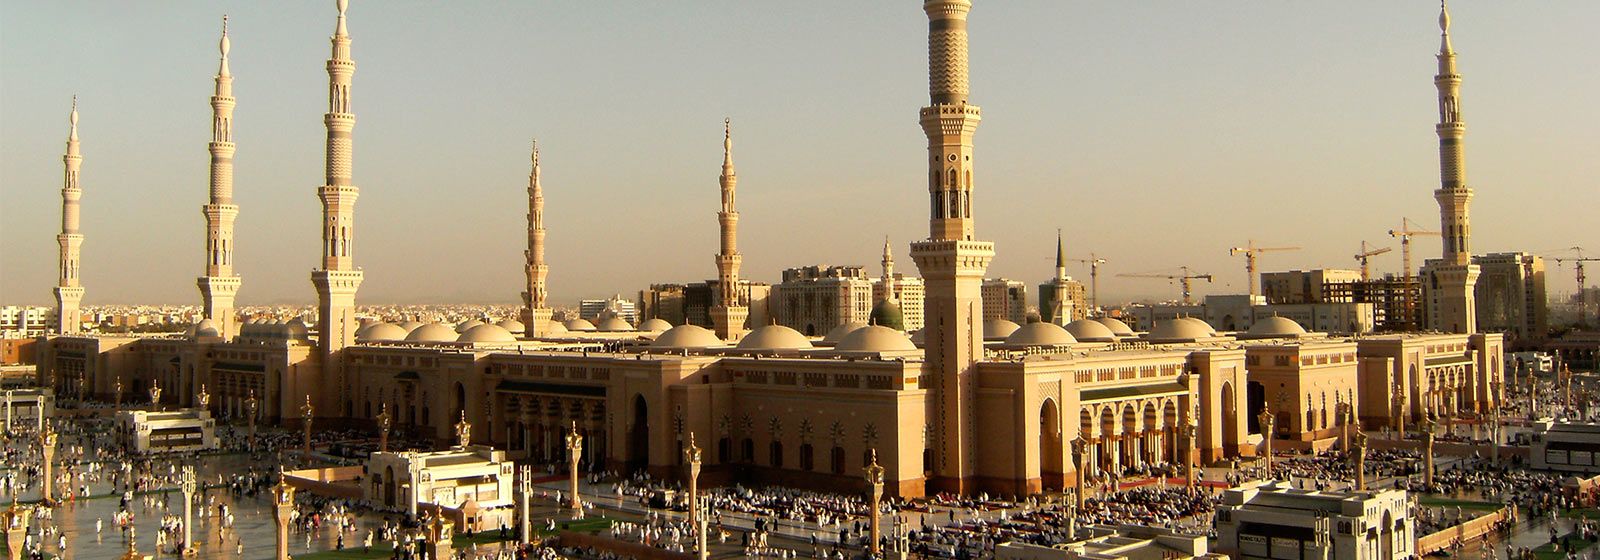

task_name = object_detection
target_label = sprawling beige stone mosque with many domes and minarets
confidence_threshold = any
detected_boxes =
[38,0,1504,496]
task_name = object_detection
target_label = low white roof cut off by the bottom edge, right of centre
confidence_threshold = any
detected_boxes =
[995,525,1227,560]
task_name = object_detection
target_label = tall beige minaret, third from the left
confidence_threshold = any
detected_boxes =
[310,0,362,393]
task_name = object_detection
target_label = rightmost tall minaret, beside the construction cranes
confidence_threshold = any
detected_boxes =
[1424,2,1478,333]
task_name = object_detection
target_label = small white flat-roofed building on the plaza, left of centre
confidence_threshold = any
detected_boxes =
[362,445,515,531]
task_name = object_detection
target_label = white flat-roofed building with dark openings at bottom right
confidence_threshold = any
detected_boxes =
[1216,482,1418,560]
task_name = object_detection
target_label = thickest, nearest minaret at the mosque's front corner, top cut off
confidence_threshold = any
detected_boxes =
[910,0,995,493]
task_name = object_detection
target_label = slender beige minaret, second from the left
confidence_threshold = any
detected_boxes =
[197,16,240,339]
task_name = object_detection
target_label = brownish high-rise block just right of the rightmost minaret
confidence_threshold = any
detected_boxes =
[1472,253,1550,339]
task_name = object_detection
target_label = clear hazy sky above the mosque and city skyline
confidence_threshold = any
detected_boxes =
[0,0,1600,306]
